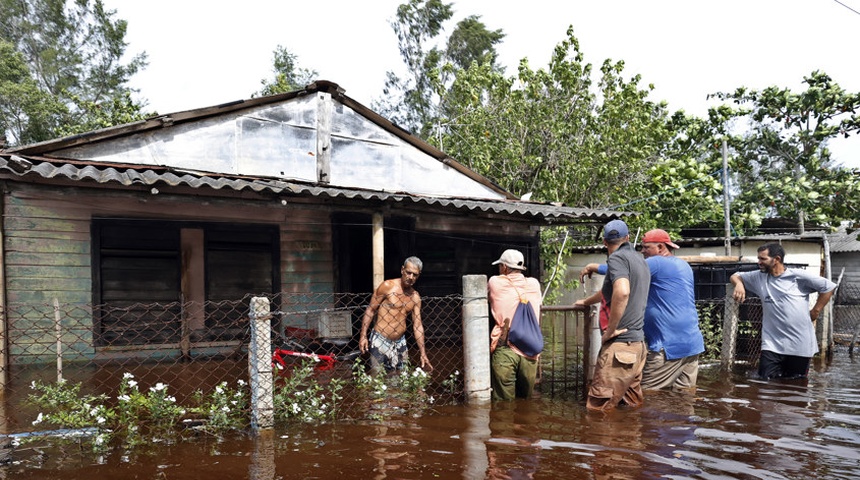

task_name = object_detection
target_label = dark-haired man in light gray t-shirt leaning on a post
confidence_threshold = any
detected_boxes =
[731,243,836,379]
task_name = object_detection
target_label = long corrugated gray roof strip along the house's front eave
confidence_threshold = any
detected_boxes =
[0,153,620,224]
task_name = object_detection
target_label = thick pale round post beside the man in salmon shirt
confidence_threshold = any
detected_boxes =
[463,275,492,403]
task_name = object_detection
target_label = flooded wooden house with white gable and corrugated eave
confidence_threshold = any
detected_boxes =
[0,81,617,371]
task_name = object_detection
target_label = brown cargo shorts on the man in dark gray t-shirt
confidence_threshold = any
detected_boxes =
[585,342,647,411]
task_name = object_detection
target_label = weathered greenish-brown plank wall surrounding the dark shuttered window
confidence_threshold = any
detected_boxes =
[3,184,334,357]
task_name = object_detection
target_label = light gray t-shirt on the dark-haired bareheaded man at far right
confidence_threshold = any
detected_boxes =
[737,268,836,357]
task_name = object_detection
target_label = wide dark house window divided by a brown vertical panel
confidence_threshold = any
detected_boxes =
[92,219,280,346]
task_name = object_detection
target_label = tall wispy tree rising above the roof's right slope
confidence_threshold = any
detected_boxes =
[373,0,504,138]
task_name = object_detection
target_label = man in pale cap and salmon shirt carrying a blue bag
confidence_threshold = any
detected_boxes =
[487,250,543,400]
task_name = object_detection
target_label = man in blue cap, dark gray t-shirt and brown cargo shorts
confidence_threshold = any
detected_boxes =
[586,220,651,411]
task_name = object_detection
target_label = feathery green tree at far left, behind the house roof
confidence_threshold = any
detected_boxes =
[0,0,146,143]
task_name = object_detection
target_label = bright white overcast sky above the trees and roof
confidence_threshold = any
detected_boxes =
[104,0,860,168]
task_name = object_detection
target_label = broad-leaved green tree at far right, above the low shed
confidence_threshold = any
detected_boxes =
[716,71,860,234]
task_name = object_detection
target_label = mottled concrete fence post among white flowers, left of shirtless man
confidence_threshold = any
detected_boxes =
[248,297,275,430]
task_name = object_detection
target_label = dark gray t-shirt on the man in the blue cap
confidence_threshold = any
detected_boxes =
[602,242,651,342]
